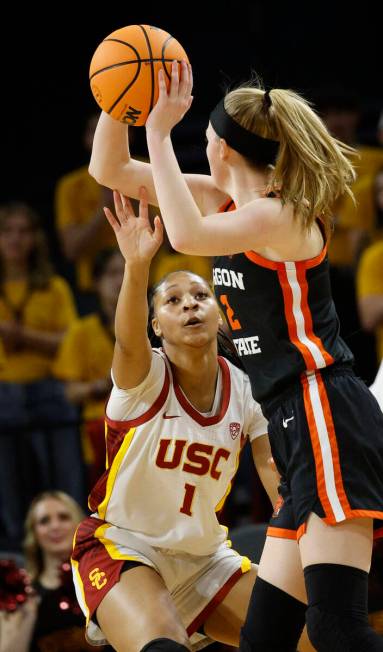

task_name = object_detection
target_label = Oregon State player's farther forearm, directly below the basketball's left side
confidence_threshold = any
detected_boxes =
[89,111,130,188]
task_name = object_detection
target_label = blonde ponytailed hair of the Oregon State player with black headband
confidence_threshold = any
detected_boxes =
[224,85,356,233]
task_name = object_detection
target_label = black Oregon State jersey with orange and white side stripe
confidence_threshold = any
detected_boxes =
[213,202,353,402]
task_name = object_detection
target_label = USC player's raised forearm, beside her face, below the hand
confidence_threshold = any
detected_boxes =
[115,262,150,355]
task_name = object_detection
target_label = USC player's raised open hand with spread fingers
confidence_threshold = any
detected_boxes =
[104,187,163,263]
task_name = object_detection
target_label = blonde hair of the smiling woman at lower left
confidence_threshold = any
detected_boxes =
[23,491,85,580]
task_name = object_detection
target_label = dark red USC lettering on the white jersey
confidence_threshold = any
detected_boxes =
[156,439,230,480]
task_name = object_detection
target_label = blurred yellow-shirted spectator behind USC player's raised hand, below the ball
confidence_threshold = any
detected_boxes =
[55,114,115,312]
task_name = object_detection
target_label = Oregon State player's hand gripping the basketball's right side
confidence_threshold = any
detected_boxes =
[146,61,193,136]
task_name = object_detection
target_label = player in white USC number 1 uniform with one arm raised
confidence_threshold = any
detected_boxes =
[72,188,288,652]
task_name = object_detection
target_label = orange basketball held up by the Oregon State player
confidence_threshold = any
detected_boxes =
[89,25,188,127]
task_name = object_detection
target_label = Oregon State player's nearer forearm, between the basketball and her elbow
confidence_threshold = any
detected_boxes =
[147,130,202,252]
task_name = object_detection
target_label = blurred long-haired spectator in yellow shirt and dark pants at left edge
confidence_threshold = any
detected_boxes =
[0,202,83,546]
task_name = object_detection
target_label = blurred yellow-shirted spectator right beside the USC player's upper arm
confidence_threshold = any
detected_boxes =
[54,249,124,490]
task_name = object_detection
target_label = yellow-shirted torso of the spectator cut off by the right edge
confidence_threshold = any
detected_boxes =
[357,240,383,361]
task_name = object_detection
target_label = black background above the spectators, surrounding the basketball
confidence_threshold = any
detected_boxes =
[0,0,383,214]
